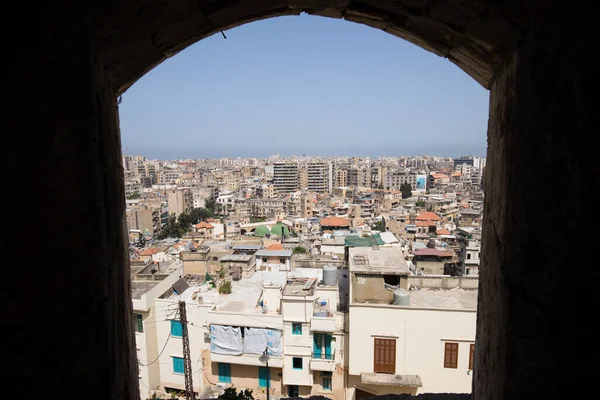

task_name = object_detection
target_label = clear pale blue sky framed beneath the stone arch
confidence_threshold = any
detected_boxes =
[119,15,489,159]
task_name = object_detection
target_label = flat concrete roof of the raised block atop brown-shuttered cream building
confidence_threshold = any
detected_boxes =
[348,246,409,275]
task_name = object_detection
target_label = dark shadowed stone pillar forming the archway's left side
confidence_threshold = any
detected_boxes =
[4,9,139,400]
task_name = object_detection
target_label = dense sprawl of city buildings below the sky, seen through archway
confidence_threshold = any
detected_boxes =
[123,155,486,400]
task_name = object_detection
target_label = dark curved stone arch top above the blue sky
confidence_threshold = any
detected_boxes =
[92,0,520,94]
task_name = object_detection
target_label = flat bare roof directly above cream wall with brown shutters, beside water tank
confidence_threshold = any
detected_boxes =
[409,288,477,310]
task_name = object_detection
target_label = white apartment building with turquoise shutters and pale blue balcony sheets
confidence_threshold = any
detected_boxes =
[148,268,345,400]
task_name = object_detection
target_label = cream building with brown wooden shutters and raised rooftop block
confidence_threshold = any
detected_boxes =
[347,247,477,400]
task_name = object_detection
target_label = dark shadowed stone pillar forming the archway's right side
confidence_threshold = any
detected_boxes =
[473,3,598,400]
